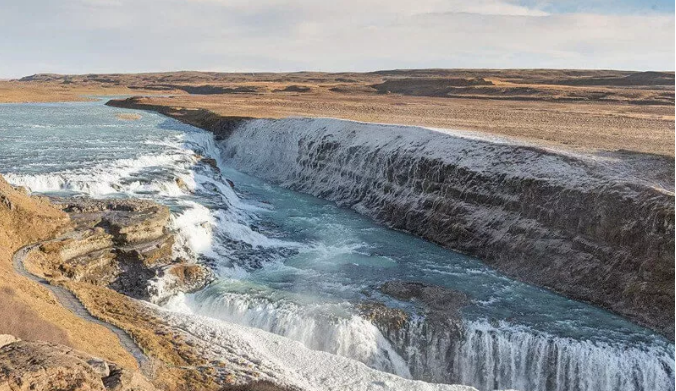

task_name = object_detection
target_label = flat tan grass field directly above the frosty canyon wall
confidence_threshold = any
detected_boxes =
[123,93,674,156]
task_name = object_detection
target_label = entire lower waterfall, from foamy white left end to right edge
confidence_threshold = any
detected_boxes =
[176,282,674,391]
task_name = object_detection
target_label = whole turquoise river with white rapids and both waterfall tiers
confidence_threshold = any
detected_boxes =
[0,102,674,391]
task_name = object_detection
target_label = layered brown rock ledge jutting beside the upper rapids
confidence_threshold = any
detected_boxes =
[34,198,213,301]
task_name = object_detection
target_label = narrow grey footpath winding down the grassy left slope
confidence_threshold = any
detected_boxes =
[12,243,148,369]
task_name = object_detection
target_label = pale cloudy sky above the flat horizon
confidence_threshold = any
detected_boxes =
[0,0,675,78]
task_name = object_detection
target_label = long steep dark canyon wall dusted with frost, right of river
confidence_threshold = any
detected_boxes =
[107,99,674,339]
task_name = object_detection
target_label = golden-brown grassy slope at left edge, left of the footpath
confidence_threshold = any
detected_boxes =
[0,176,143,368]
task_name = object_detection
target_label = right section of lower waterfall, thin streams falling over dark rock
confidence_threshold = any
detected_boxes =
[378,318,674,391]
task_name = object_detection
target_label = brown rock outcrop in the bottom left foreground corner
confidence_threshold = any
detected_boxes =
[0,341,155,391]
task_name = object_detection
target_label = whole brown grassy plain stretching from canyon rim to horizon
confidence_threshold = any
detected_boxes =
[0,69,674,156]
